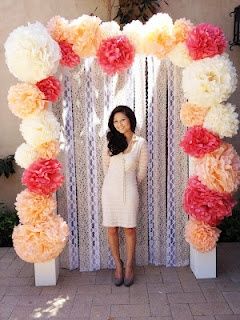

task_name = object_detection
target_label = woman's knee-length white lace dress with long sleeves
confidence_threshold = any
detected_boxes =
[102,136,148,228]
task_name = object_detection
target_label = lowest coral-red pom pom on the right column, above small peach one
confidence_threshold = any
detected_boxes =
[183,176,236,226]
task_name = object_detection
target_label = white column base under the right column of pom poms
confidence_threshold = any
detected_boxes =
[190,246,217,279]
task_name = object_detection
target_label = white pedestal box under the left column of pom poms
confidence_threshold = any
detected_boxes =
[34,257,59,287]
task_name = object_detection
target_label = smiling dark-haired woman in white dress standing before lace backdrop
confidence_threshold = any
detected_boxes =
[102,106,147,286]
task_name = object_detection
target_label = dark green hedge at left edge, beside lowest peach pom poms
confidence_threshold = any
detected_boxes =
[0,202,19,247]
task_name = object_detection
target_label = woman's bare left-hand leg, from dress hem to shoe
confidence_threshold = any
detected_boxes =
[108,227,122,278]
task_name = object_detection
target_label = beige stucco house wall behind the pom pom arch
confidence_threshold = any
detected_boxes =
[0,0,240,204]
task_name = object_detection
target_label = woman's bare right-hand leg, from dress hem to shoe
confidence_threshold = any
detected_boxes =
[124,228,136,279]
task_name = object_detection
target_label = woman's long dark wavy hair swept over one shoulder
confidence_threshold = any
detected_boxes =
[107,106,137,156]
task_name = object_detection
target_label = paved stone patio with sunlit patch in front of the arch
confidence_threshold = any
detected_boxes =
[0,243,240,320]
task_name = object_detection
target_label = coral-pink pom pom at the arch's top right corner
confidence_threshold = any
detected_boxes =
[186,23,227,60]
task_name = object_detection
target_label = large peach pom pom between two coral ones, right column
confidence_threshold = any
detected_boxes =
[195,143,240,193]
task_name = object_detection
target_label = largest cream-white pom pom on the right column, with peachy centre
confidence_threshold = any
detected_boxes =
[182,55,237,107]
